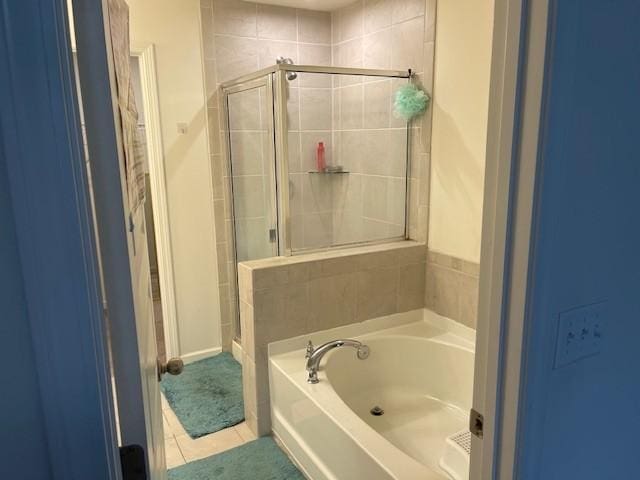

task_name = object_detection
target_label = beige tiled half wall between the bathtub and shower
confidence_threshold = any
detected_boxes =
[238,241,426,435]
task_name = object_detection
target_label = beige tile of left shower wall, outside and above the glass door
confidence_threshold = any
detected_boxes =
[200,0,331,350]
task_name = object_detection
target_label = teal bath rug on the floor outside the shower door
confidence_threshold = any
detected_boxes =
[160,352,244,438]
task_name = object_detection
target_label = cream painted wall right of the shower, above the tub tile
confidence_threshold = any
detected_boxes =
[429,0,493,262]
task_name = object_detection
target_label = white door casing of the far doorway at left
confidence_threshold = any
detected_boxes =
[131,44,180,357]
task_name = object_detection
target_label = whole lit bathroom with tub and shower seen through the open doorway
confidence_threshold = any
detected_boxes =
[72,0,493,480]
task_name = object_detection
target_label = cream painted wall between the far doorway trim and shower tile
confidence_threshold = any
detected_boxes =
[128,0,221,356]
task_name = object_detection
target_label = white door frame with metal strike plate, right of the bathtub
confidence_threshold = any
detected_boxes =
[470,0,548,480]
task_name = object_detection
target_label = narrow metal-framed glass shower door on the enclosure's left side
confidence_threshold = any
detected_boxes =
[227,77,278,262]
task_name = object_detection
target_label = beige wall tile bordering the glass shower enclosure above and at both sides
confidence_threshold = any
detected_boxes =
[200,0,436,344]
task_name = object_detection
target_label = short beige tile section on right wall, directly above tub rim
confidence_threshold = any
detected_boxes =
[425,250,480,329]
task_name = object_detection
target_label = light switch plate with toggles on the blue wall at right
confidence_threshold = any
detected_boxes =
[555,302,607,368]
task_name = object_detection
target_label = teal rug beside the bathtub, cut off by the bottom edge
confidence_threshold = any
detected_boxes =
[169,437,304,480]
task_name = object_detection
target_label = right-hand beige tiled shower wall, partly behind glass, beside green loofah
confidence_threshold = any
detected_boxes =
[332,0,435,242]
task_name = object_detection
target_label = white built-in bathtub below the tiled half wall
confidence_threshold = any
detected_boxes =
[269,310,474,480]
